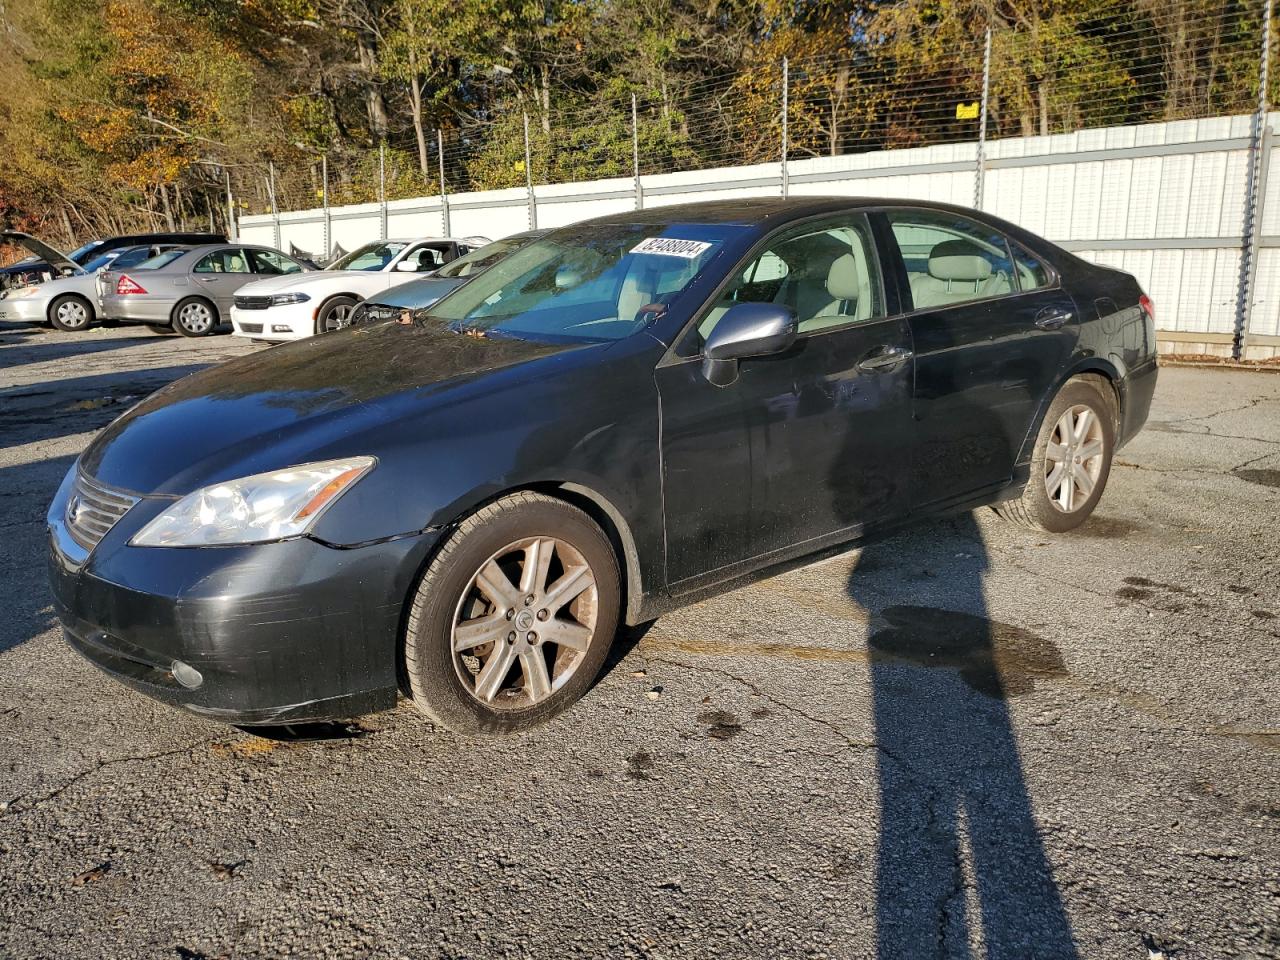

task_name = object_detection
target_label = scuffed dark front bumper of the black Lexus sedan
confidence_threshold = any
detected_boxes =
[49,478,435,724]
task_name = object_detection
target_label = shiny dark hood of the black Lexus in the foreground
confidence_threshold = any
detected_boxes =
[81,323,611,495]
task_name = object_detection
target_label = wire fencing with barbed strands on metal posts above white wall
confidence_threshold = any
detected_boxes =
[230,0,1276,221]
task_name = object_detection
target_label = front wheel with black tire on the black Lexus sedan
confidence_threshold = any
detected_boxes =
[404,493,621,736]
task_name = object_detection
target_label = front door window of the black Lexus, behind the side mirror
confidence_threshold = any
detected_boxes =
[698,214,884,339]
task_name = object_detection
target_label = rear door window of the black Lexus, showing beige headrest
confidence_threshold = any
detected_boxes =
[888,210,1018,310]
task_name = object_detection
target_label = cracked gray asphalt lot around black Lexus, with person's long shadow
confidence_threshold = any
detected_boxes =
[0,325,1280,960]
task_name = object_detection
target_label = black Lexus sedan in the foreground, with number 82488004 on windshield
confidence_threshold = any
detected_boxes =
[49,197,1156,733]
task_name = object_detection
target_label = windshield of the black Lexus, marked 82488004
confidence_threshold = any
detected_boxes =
[429,224,745,340]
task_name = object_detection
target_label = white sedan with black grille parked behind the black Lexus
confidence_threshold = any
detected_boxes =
[232,237,489,340]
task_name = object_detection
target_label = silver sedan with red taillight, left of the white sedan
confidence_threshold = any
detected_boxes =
[97,243,311,337]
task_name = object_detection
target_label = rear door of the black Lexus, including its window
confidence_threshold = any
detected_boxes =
[881,207,1079,508]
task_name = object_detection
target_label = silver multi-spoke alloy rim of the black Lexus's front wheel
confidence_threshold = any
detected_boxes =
[449,536,599,709]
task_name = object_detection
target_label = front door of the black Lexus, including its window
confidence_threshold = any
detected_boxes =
[657,214,913,593]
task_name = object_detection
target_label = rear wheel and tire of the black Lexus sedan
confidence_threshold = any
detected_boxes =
[995,376,1117,534]
